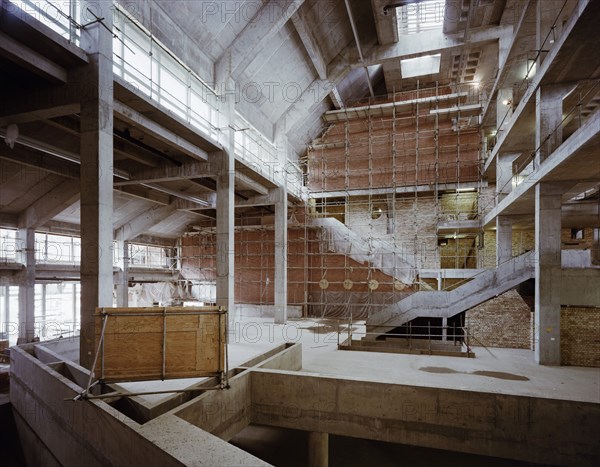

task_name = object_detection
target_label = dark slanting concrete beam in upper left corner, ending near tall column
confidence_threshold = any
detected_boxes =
[0,31,68,83]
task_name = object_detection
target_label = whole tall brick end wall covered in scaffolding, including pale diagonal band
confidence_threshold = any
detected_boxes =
[176,87,494,319]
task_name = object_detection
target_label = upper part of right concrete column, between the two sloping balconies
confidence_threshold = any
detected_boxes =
[535,84,574,168]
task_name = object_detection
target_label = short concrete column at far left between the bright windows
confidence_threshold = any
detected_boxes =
[17,229,35,343]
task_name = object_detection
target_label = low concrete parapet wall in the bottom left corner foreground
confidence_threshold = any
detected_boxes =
[10,346,181,467]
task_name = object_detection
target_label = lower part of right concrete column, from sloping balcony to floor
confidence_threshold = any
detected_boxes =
[534,183,563,365]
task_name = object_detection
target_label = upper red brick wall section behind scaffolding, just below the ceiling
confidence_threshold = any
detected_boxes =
[308,108,480,191]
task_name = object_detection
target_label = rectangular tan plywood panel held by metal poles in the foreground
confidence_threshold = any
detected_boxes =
[95,307,227,382]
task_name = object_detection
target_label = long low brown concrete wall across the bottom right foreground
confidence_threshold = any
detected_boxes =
[252,370,600,466]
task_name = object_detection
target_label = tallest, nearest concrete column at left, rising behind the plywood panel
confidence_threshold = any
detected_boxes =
[79,1,113,368]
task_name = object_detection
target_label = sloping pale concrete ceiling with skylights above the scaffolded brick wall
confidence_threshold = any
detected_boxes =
[148,0,518,159]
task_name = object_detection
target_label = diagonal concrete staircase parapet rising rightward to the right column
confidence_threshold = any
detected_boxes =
[367,251,535,333]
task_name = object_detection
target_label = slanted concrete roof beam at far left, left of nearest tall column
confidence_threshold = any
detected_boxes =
[19,180,79,229]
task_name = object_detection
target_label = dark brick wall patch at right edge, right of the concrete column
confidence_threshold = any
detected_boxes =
[560,306,600,368]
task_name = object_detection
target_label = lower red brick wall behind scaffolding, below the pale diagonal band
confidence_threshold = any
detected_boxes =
[182,228,415,314]
